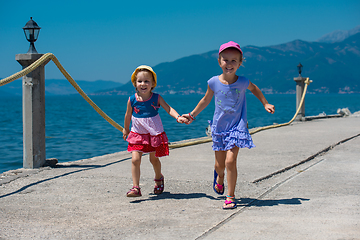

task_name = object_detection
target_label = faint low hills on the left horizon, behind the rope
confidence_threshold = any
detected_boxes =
[0,79,123,96]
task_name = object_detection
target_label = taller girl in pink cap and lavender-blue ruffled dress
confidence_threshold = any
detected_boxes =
[183,41,275,209]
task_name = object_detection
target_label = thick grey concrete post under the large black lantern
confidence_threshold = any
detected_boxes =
[15,53,46,168]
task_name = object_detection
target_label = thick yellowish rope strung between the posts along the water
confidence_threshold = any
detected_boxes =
[0,53,312,148]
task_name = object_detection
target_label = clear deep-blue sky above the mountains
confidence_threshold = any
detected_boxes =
[0,0,360,83]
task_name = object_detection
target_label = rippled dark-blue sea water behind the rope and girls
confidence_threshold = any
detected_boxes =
[0,93,360,173]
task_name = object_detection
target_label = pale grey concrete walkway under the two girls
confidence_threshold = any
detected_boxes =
[0,114,360,240]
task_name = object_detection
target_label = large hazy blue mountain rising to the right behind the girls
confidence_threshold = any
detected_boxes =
[94,33,360,95]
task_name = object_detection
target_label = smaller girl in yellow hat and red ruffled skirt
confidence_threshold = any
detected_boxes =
[123,65,187,197]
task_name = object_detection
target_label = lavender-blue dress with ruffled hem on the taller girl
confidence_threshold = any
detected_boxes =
[208,76,255,151]
